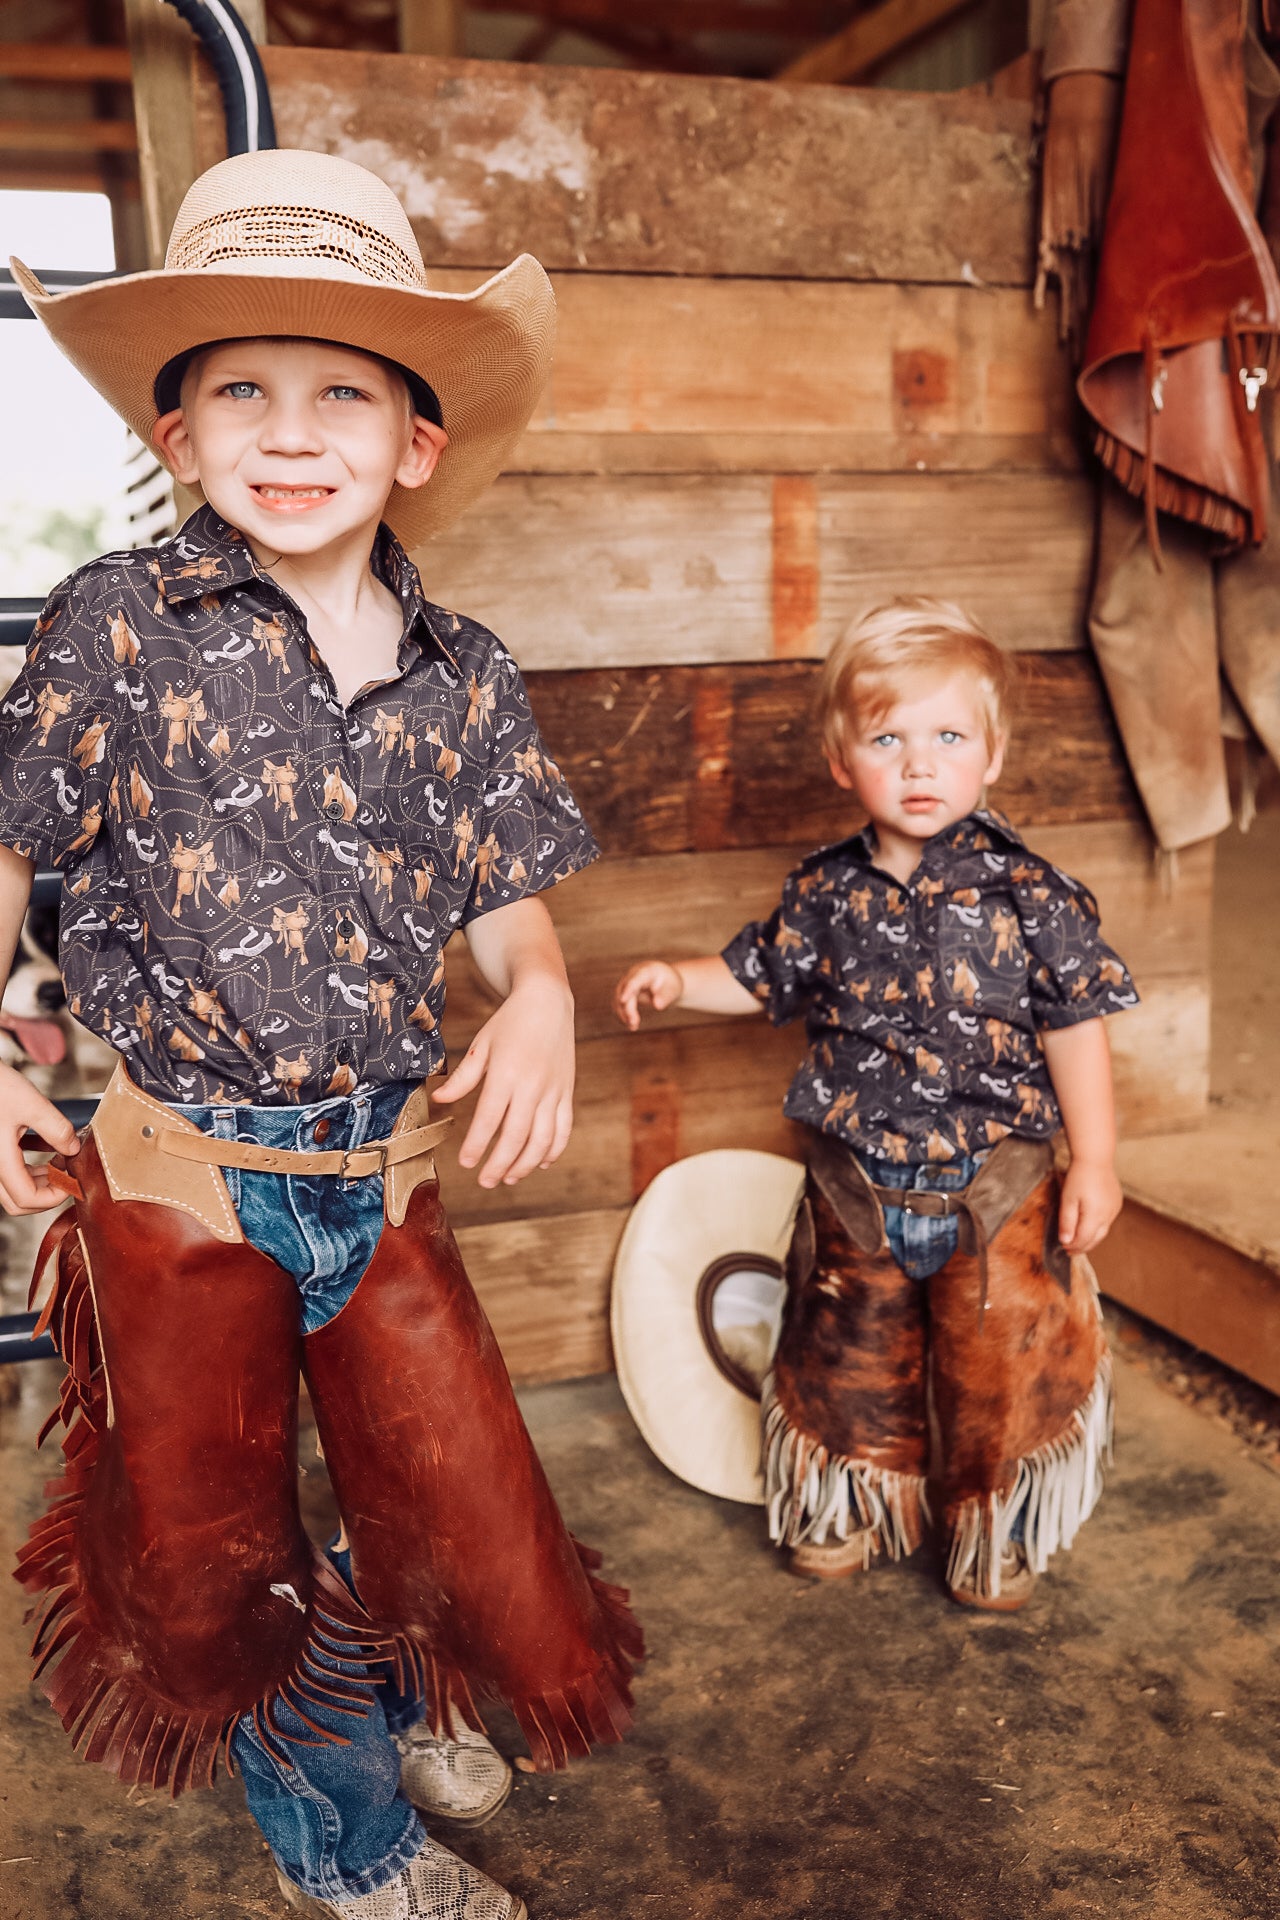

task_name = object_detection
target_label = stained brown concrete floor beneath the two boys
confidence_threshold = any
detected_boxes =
[0,1357,1280,1920]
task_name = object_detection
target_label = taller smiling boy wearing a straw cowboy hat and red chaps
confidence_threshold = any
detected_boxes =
[0,152,639,1920]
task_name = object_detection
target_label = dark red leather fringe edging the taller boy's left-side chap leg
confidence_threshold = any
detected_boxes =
[15,1210,393,1799]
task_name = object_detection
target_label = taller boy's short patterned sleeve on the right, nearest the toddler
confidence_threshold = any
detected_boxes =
[462,645,601,925]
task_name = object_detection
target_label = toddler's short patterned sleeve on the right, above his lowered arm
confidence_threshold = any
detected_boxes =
[1017,862,1138,1029]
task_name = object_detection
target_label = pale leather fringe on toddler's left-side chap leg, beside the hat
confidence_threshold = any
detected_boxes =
[764,1375,929,1565]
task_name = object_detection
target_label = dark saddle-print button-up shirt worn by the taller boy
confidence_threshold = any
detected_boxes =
[0,507,597,1104]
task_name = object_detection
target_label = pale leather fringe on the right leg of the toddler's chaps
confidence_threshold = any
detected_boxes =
[946,1354,1115,1599]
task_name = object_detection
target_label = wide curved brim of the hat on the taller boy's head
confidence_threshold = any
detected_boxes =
[10,253,555,547]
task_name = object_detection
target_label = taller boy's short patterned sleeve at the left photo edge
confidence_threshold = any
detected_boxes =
[0,572,119,868]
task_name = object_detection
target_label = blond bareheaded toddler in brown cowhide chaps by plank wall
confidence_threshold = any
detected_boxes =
[616,599,1136,1609]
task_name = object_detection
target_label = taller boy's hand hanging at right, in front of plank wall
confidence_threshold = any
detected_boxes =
[432,977,574,1187]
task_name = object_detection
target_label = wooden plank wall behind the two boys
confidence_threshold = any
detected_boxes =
[189,48,1211,1379]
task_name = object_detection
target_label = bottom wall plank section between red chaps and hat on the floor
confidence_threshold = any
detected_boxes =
[457,1206,629,1386]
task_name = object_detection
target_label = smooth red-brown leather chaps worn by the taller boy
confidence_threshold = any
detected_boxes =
[17,1089,643,1793]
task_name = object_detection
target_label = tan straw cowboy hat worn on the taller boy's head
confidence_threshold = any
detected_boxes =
[10,148,555,547]
